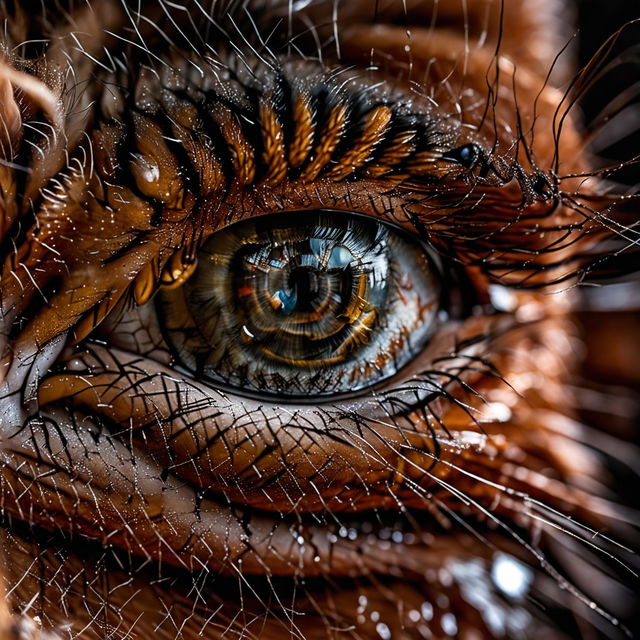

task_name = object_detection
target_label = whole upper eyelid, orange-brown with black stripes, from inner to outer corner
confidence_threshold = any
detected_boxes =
[3,56,606,380]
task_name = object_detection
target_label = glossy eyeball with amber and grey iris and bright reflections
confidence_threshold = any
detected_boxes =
[157,210,440,397]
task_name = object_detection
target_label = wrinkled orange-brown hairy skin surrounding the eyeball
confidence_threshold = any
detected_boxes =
[0,0,637,640]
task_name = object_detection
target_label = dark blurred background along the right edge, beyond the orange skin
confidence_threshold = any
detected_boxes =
[574,0,640,638]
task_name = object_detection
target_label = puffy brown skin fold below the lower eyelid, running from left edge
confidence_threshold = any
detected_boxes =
[5,400,498,578]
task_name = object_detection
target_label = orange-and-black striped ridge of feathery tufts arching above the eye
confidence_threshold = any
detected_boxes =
[91,67,546,264]
